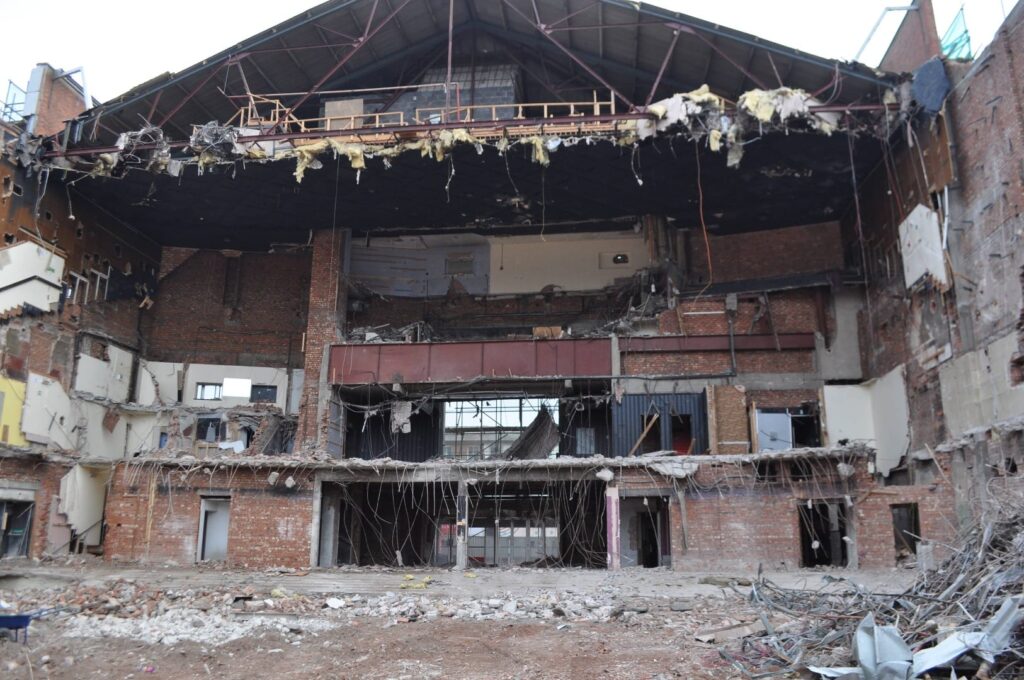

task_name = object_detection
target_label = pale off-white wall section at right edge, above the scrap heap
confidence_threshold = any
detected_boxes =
[939,332,1024,436]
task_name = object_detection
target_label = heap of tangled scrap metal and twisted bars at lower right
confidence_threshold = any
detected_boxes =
[719,495,1024,679]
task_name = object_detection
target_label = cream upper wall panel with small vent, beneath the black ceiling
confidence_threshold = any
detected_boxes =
[490,231,650,295]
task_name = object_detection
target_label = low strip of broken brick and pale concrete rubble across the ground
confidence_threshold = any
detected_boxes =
[4,573,715,645]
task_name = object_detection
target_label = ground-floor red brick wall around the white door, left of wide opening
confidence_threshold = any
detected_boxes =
[103,464,314,568]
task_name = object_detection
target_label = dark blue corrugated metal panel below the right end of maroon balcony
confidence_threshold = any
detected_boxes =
[611,392,708,456]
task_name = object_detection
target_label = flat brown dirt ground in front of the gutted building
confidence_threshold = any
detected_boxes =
[0,565,912,680]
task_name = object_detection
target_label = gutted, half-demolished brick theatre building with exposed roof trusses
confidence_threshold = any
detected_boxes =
[0,0,1024,568]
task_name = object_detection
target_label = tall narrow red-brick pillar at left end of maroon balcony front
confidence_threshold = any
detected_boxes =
[295,229,348,451]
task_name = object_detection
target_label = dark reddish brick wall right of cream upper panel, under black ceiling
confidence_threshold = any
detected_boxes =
[686,222,843,284]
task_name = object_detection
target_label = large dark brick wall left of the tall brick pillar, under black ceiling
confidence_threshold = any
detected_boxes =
[142,251,310,367]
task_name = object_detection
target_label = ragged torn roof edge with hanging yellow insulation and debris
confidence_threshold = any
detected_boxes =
[18,85,902,182]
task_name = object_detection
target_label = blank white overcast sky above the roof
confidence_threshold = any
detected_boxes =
[0,0,1016,101]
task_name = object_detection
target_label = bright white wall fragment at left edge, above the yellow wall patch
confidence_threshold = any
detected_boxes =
[0,241,65,311]
